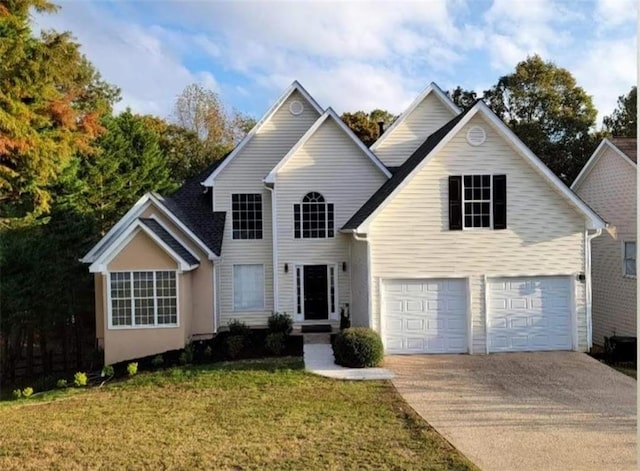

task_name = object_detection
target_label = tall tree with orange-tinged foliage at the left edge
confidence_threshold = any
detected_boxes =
[0,0,119,226]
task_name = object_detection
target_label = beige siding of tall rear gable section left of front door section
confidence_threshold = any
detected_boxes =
[214,91,319,326]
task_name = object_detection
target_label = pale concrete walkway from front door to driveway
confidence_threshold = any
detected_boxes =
[304,343,394,380]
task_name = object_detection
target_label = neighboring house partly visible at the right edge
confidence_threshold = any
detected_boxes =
[571,138,637,345]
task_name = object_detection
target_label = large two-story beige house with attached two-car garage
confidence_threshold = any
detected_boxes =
[83,82,605,363]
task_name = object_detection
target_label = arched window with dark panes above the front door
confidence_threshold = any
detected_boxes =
[293,191,334,239]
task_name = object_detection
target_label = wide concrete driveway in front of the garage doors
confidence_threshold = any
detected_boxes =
[384,352,637,471]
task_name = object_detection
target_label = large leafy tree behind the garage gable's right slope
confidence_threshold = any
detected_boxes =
[484,55,596,183]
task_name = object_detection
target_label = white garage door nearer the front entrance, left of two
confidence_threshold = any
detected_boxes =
[382,279,467,354]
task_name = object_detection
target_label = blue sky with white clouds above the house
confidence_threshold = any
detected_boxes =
[34,0,638,122]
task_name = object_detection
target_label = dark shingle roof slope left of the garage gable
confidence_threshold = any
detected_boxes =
[342,107,473,230]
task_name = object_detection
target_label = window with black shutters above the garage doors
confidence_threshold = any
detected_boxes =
[449,175,507,230]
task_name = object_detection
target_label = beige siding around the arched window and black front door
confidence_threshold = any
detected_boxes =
[275,119,386,319]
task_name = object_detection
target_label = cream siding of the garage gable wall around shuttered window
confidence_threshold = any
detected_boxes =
[369,116,587,352]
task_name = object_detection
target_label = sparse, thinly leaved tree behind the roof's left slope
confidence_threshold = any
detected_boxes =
[174,83,255,162]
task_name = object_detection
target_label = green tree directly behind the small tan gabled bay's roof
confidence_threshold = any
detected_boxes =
[79,110,176,234]
